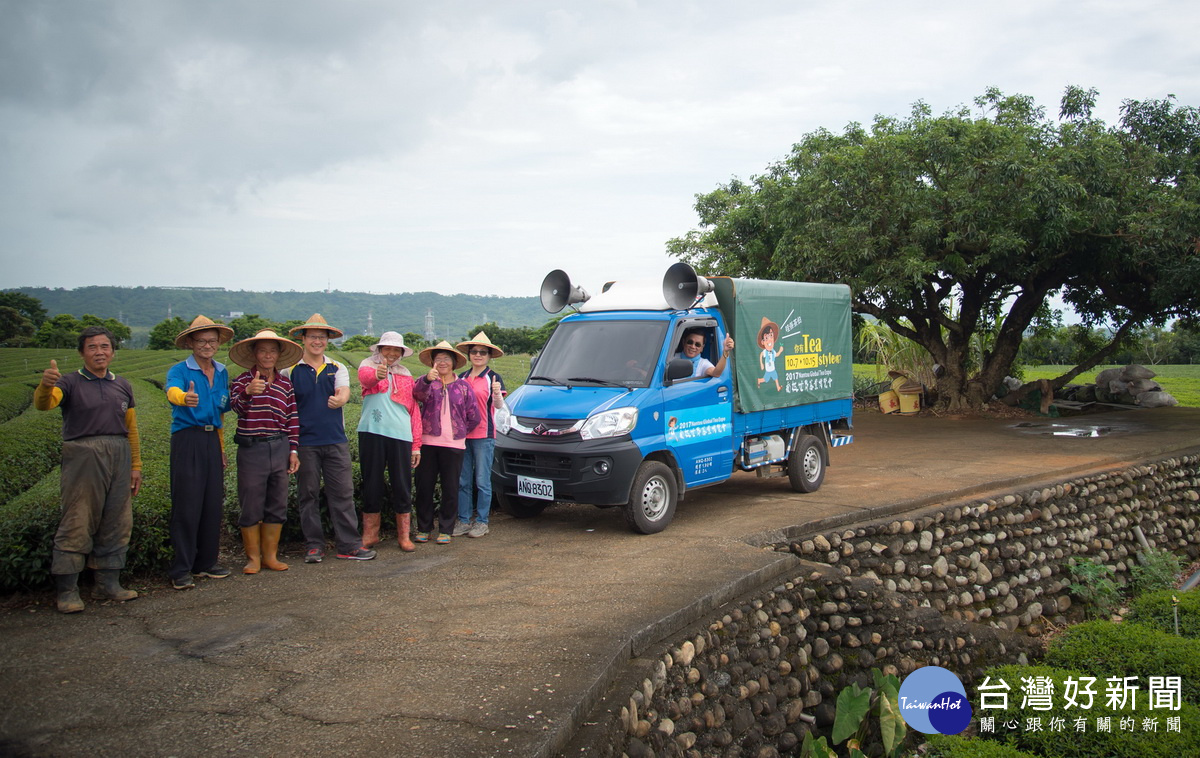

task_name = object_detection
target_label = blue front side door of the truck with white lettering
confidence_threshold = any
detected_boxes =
[661,319,733,488]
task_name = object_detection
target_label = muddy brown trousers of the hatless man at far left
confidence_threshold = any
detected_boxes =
[50,435,133,574]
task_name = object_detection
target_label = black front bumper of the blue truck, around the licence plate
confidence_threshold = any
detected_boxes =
[492,435,642,506]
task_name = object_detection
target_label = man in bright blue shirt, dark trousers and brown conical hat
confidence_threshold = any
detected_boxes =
[167,315,233,590]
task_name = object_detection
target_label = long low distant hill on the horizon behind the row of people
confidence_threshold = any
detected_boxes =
[12,287,550,341]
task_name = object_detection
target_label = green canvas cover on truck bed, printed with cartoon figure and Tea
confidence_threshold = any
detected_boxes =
[710,277,853,413]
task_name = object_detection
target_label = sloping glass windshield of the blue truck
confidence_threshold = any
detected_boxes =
[528,320,667,387]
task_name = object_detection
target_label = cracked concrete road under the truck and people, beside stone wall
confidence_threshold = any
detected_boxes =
[0,408,1200,757]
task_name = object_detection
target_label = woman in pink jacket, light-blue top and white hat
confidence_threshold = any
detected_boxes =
[359,332,421,553]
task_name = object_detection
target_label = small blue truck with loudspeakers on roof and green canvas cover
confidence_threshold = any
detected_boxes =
[492,263,853,534]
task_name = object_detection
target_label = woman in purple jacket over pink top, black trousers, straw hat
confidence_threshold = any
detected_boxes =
[413,339,481,545]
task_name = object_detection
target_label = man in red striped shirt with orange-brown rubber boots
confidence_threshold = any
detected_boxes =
[229,329,304,573]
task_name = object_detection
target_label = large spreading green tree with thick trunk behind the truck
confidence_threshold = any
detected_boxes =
[668,88,1200,408]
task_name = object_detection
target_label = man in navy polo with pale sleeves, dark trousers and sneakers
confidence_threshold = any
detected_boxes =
[281,313,376,564]
